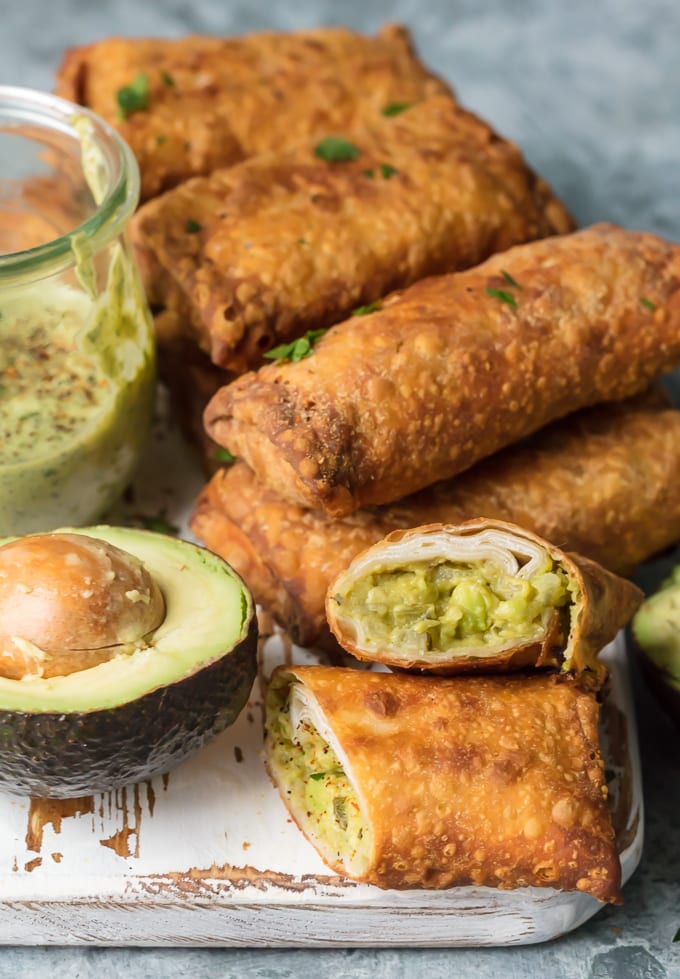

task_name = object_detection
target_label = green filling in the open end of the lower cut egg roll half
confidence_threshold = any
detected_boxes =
[267,684,368,866]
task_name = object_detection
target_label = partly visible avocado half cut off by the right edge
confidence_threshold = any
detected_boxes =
[632,565,680,727]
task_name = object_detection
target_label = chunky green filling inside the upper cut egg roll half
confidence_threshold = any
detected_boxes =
[336,560,571,656]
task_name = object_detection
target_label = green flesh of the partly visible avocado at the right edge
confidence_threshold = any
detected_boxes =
[633,565,680,693]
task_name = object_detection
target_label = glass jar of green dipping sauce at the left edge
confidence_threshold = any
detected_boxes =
[0,86,155,536]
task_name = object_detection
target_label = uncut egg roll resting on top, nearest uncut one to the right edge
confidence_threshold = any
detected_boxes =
[205,224,680,516]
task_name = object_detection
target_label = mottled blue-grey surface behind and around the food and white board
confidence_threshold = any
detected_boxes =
[0,0,680,979]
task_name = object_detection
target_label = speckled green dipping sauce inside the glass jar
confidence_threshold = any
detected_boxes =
[0,242,155,535]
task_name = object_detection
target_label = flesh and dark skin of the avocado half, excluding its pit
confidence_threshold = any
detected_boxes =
[0,526,257,799]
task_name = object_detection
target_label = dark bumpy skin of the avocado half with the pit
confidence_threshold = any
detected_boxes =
[0,611,257,799]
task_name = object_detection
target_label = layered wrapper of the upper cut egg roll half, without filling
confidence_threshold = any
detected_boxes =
[326,518,643,687]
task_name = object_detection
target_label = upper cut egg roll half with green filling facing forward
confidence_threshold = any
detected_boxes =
[326,519,642,684]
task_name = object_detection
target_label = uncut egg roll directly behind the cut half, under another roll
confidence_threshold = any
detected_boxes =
[192,395,680,645]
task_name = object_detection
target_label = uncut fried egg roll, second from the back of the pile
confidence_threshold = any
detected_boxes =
[133,95,573,371]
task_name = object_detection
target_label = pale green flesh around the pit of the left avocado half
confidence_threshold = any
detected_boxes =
[0,526,252,714]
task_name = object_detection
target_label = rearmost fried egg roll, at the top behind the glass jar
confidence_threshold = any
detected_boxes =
[56,25,450,200]
